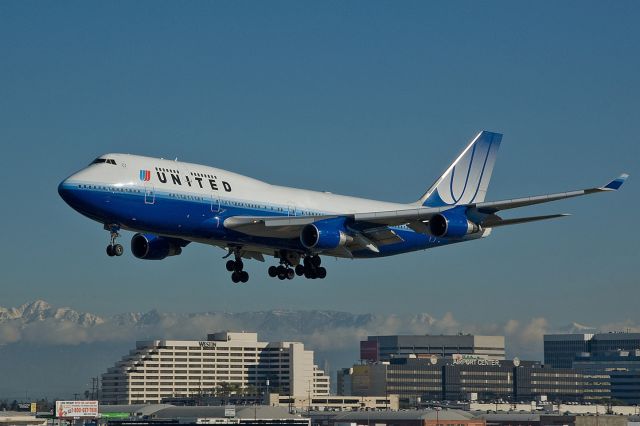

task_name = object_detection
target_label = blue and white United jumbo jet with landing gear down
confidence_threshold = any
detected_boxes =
[58,131,628,283]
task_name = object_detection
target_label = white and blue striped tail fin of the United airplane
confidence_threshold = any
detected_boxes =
[416,130,502,207]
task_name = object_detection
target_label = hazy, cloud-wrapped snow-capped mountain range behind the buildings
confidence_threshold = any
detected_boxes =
[0,300,640,399]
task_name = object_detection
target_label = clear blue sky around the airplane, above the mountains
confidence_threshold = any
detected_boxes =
[0,1,640,324]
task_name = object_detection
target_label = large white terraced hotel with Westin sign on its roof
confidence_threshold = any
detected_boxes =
[100,332,329,404]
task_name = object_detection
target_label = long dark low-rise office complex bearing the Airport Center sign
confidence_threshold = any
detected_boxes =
[338,354,585,406]
